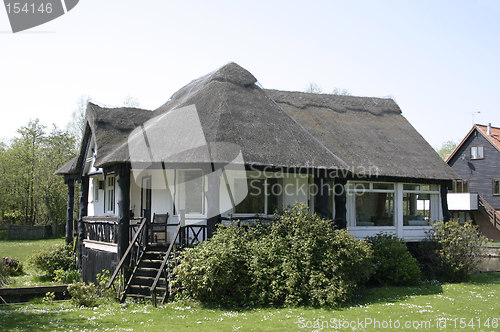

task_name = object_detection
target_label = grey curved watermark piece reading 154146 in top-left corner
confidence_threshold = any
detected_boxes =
[4,0,79,32]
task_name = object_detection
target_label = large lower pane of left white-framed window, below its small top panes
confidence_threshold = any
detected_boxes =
[356,193,394,226]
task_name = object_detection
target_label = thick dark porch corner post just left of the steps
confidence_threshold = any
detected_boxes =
[115,164,130,263]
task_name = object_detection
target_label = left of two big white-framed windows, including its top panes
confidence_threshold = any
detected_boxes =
[348,182,394,226]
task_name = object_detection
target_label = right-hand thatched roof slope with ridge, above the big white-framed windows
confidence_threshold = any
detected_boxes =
[266,90,456,179]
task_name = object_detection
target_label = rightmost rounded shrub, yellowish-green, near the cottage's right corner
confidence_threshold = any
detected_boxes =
[432,220,486,281]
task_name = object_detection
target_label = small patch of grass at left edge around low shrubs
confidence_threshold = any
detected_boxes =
[0,238,64,287]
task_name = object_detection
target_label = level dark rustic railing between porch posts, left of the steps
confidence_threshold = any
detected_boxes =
[83,216,118,243]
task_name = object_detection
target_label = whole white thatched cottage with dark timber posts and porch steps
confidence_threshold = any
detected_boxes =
[57,63,457,299]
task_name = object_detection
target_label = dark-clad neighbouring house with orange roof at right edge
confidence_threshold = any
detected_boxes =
[446,124,500,241]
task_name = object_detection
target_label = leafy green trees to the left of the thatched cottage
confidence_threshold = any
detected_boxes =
[0,119,74,225]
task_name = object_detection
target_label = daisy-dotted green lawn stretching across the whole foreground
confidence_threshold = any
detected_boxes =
[0,273,500,331]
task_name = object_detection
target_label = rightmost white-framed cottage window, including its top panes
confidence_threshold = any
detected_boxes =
[403,184,439,226]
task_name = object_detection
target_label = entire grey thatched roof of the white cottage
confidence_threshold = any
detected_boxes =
[56,63,455,179]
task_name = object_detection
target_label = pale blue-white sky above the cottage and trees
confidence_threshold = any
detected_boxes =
[0,0,500,147]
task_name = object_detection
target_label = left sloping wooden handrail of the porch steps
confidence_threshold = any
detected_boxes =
[106,218,147,297]
